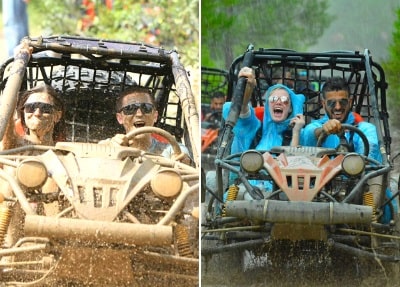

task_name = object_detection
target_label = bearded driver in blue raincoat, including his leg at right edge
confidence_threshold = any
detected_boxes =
[303,77,398,227]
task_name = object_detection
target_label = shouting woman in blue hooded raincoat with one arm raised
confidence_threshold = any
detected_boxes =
[223,67,305,154]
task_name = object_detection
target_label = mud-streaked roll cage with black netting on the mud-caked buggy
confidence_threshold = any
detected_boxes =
[0,36,199,168]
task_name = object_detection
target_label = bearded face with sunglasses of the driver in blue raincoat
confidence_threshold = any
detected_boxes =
[322,90,352,122]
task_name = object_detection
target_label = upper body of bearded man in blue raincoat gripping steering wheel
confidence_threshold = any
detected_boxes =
[304,77,382,161]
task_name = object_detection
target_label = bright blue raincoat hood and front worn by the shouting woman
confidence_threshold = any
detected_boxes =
[256,84,305,150]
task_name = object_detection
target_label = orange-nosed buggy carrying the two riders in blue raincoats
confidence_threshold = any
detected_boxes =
[201,46,400,283]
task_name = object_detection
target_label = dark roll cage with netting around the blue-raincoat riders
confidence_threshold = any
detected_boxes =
[219,45,391,161]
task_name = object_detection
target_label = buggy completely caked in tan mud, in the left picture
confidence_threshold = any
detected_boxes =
[0,36,199,286]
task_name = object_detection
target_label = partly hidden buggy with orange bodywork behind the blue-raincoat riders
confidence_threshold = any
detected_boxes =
[201,67,228,173]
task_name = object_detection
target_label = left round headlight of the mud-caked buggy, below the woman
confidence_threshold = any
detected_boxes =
[16,158,47,188]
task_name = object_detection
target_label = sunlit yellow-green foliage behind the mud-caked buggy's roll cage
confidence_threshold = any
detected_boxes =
[30,0,199,67]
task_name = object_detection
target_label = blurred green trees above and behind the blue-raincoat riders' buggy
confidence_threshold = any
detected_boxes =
[201,0,333,68]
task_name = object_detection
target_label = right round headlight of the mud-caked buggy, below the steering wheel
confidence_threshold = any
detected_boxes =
[150,169,183,198]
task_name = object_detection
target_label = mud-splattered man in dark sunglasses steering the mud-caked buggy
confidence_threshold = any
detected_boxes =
[100,86,189,162]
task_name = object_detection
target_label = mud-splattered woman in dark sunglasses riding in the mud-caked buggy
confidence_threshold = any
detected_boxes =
[0,85,65,250]
